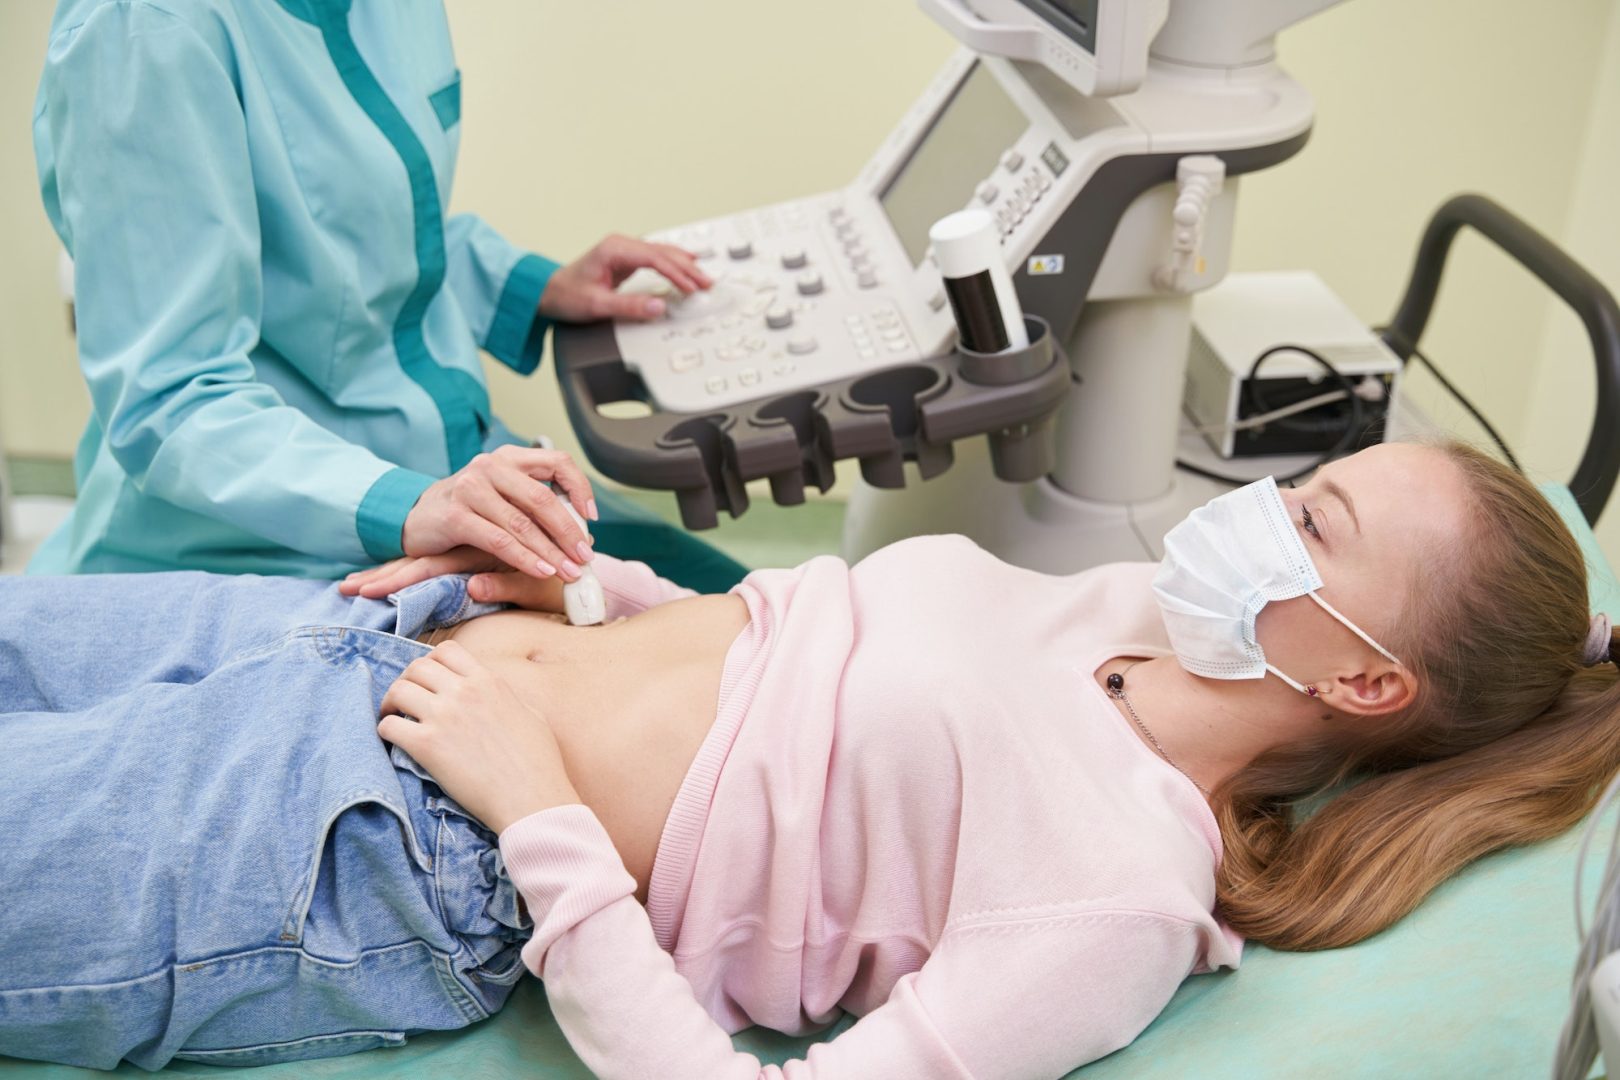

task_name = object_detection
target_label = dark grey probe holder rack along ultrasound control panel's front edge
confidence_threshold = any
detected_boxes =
[554,316,1071,529]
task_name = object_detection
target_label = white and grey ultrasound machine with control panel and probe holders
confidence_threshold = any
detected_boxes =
[556,0,1337,572]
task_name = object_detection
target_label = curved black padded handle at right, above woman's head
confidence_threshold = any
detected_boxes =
[1383,194,1620,523]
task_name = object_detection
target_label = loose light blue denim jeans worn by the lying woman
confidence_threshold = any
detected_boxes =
[0,573,528,1069]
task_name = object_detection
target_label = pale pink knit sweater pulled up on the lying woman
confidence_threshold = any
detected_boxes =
[501,536,1241,1080]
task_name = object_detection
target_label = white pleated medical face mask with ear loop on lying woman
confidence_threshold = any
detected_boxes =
[1153,476,1400,698]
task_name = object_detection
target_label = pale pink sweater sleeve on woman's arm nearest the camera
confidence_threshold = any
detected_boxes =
[501,805,1196,1080]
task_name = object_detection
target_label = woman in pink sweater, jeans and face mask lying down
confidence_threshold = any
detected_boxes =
[0,445,1620,1080]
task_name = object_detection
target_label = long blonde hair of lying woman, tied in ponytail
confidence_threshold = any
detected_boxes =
[1213,444,1620,949]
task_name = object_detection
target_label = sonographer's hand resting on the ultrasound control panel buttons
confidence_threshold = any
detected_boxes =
[539,235,714,322]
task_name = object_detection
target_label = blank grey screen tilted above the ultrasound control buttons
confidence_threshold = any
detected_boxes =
[878,63,1029,266]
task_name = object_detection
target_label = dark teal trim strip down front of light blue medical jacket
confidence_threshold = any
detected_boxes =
[277,0,491,473]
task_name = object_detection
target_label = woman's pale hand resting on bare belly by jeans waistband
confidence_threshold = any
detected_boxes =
[377,641,580,834]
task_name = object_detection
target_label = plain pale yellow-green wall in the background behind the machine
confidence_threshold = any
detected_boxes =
[0,0,1620,551]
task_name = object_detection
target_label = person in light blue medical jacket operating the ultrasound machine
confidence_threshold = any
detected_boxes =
[31,0,729,592]
